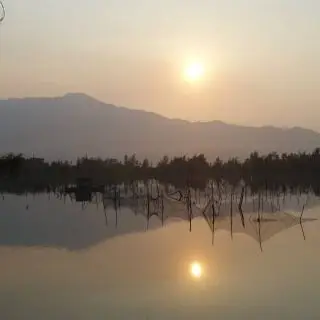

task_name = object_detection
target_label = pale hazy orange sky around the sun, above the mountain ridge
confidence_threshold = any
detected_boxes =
[0,0,320,130]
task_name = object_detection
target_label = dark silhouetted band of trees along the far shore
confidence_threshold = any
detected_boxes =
[0,148,320,194]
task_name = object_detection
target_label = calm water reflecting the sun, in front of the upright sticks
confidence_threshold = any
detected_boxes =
[0,195,320,320]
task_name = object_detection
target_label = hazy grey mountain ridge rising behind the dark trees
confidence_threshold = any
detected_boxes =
[0,93,320,161]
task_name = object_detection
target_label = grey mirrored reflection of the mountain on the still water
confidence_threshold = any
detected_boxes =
[0,190,320,250]
